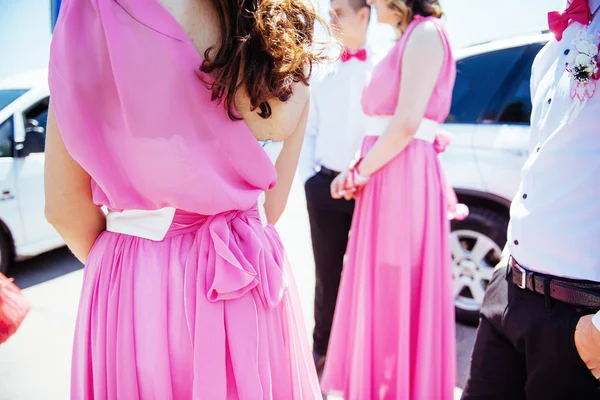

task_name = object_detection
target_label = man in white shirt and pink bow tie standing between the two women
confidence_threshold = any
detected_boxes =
[298,0,373,372]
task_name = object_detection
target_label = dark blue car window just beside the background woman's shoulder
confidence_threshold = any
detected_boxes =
[446,46,527,123]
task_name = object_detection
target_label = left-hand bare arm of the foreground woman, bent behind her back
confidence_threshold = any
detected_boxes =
[44,106,106,263]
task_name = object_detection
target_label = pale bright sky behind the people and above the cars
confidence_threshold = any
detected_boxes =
[0,0,564,79]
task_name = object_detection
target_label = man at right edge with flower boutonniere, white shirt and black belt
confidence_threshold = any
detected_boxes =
[463,0,600,399]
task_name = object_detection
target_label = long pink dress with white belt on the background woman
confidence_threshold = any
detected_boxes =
[321,17,465,400]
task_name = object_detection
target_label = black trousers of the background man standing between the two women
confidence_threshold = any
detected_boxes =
[304,173,354,356]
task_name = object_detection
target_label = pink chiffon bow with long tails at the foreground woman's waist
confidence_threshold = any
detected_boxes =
[168,208,288,399]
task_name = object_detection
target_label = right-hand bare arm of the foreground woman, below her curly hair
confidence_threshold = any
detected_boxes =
[265,95,310,224]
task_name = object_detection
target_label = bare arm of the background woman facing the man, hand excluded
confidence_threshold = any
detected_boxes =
[352,22,444,176]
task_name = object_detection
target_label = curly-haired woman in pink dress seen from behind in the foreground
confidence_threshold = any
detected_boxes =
[46,0,328,400]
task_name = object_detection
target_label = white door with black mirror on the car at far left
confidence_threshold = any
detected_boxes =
[15,97,60,247]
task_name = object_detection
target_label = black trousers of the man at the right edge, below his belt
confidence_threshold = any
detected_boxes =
[462,267,600,400]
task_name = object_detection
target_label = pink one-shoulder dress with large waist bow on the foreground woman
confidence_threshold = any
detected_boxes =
[49,0,320,400]
